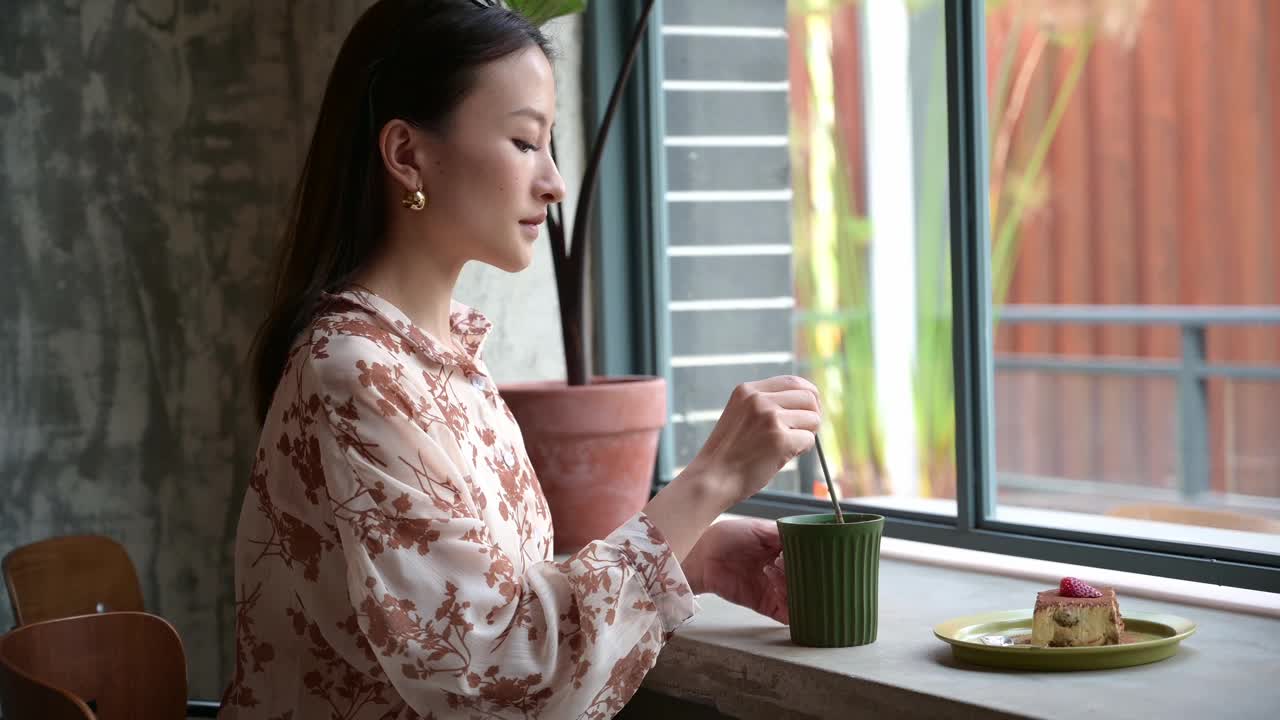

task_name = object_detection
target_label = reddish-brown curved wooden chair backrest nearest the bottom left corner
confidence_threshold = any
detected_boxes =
[0,612,187,720]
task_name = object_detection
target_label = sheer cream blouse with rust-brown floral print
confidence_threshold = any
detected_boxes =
[220,290,695,720]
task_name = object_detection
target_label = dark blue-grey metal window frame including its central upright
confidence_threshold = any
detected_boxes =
[584,0,1280,592]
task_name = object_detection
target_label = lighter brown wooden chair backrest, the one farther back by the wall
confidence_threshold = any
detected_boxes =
[0,536,145,625]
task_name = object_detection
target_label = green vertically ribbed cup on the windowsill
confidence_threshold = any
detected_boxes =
[778,512,884,647]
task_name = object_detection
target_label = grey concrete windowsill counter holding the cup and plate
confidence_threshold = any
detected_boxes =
[644,538,1280,720]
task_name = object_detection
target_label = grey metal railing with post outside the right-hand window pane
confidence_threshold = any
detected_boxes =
[995,305,1280,498]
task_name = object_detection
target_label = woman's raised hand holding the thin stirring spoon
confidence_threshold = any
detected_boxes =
[685,375,822,507]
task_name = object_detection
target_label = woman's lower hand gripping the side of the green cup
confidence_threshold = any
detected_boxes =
[684,518,790,625]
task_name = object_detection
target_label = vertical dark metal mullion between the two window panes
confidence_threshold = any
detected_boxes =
[946,0,995,532]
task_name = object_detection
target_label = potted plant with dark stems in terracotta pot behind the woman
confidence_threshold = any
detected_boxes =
[499,0,667,553]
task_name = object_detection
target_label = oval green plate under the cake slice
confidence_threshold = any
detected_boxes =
[933,610,1196,670]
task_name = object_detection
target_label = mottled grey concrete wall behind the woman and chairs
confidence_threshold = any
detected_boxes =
[0,0,580,697]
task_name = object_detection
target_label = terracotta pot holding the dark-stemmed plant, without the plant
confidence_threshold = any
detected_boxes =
[498,377,667,553]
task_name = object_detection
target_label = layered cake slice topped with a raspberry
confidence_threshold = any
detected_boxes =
[1032,578,1124,647]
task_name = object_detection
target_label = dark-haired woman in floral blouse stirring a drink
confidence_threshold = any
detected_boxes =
[221,0,819,720]
